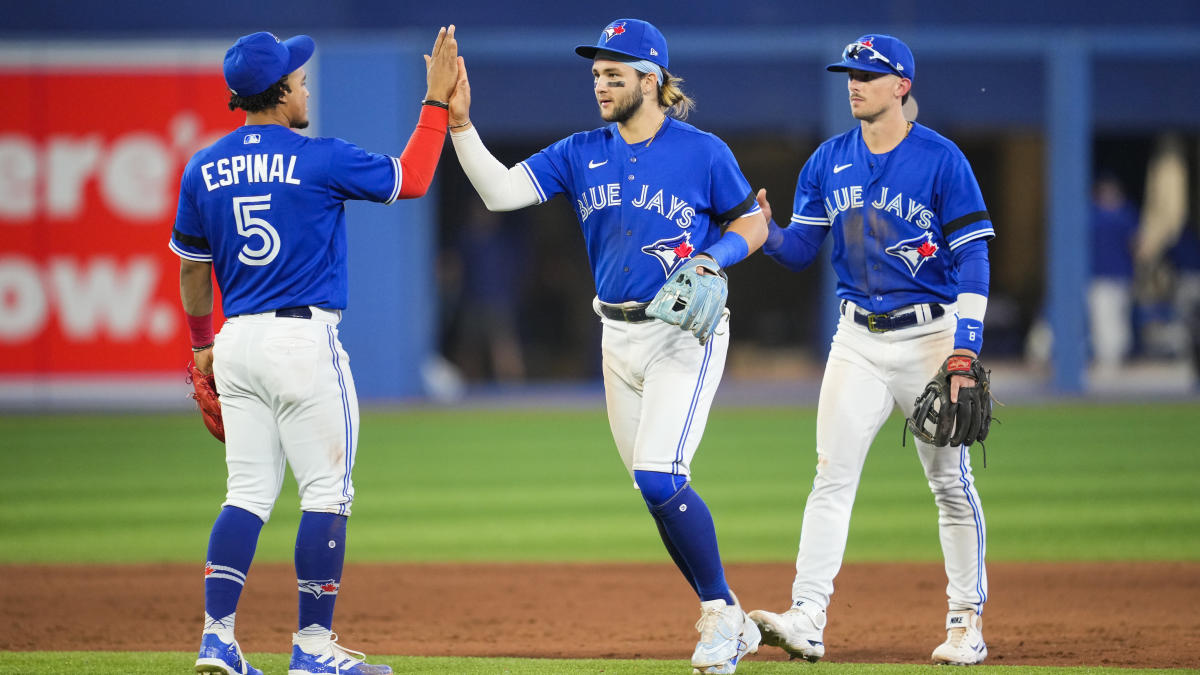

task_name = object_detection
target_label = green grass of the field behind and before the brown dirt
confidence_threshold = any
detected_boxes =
[0,404,1200,675]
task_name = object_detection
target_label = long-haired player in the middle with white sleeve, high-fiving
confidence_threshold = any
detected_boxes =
[450,19,766,673]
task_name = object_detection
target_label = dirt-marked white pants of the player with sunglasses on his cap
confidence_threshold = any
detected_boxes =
[792,304,988,614]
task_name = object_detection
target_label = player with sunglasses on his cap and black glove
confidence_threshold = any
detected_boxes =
[750,35,995,664]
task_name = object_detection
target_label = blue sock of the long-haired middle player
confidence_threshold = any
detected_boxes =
[634,471,733,605]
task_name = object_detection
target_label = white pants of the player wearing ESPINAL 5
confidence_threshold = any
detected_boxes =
[212,307,359,521]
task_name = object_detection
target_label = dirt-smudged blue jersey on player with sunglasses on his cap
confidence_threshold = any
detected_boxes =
[792,123,995,312]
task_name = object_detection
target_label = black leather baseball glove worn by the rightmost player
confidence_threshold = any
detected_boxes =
[908,354,991,448]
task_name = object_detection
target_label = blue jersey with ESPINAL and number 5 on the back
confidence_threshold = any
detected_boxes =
[170,125,402,316]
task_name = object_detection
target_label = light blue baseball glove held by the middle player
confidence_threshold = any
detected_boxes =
[646,258,730,345]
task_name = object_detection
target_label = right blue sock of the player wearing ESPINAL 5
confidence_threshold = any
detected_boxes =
[295,510,349,634]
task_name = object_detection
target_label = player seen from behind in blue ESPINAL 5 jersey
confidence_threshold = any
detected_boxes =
[170,25,457,675]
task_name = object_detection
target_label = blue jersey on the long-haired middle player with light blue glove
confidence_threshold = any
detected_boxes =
[520,117,761,304]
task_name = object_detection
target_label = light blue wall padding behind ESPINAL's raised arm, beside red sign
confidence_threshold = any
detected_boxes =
[310,37,440,401]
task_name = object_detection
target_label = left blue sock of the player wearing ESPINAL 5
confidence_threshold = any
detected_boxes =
[204,506,263,629]
